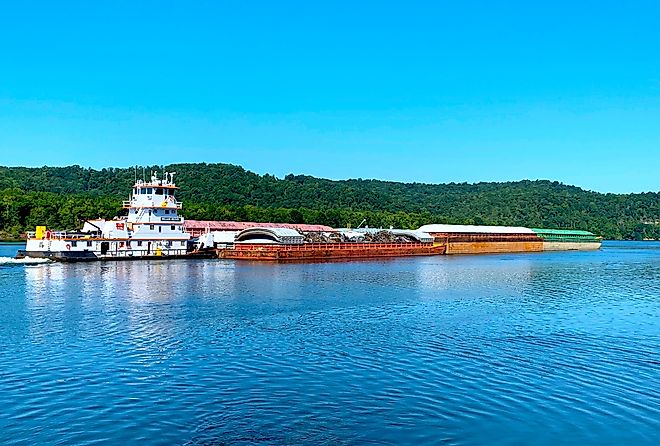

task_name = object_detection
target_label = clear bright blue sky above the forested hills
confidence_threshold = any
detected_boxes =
[0,1,660,192]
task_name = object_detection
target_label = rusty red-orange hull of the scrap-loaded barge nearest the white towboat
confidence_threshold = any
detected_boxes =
[216,243,446,261]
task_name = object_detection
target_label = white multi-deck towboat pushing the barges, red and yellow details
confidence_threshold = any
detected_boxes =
[16,172,212,262]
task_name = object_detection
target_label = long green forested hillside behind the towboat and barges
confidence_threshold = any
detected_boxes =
[0,164,660,239]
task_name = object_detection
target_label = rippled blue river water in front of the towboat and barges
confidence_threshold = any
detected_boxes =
[0,242,660,445]
